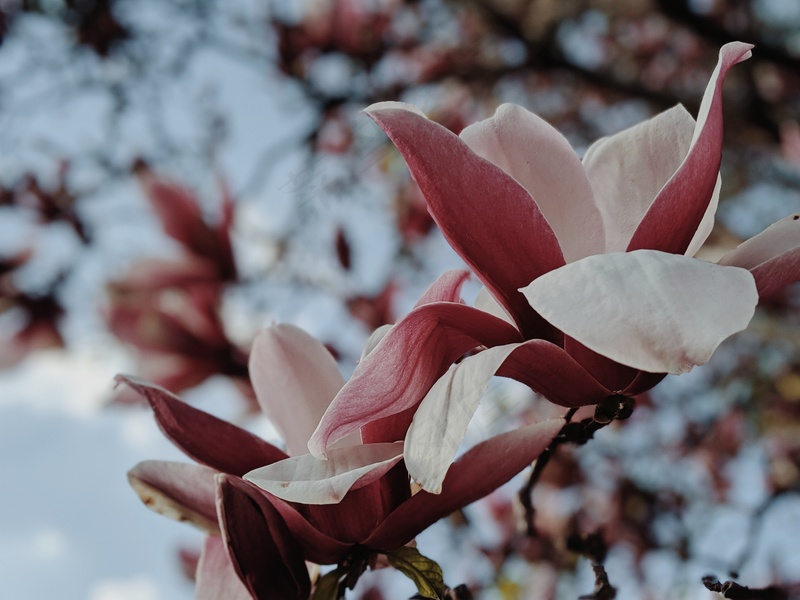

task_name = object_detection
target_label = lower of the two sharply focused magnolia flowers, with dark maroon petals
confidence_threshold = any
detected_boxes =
[122,322,563,599]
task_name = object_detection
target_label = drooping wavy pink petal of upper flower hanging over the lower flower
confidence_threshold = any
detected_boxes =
[308,302,522,458]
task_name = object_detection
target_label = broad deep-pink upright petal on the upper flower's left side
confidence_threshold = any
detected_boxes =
[366,102,564,339]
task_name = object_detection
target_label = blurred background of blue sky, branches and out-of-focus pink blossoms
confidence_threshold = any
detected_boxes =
[0,0,800,600]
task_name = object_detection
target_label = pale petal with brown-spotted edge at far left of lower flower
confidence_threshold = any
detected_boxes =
[128,460,219,533]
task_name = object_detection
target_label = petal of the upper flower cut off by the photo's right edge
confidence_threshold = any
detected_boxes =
[719,214,800,298]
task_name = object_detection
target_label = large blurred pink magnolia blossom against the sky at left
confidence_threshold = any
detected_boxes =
[104,171,252,402]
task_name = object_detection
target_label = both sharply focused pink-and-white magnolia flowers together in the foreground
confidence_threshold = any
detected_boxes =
[126,43,800,599]
